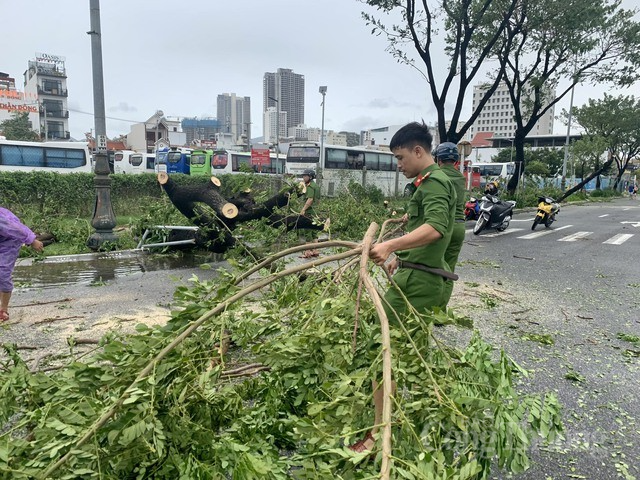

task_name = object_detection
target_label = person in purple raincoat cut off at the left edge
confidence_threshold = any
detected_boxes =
[0,207,44,322]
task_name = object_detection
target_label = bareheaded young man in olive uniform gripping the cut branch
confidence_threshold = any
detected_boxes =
[370,122,457,320]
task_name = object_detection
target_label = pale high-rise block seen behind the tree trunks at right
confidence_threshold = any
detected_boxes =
[469,82,554,138]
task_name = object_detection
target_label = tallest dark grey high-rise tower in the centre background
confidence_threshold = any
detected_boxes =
[262,68,304,139]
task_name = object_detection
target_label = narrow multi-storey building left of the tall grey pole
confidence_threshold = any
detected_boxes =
[24,53,70,140]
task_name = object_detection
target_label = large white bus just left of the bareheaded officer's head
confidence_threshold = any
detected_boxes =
[286,142,400,197]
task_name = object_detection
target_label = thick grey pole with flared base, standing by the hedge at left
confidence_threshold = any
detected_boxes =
[87,0,118,250]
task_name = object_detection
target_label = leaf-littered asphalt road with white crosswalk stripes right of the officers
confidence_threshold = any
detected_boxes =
[456,199,640,479]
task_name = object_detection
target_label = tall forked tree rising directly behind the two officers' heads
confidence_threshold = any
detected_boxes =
[363,0,522,143]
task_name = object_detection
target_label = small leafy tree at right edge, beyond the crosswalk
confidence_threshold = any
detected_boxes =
[574,93,640,188]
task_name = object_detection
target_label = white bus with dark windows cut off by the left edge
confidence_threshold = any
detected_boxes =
[0,139,92,173]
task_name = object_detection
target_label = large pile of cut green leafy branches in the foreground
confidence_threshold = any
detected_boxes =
[0,227,561,480]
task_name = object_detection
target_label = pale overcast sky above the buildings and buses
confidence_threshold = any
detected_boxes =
[0,0,640,139]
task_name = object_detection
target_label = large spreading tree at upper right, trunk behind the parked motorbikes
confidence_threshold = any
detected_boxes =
[500,0,640,192]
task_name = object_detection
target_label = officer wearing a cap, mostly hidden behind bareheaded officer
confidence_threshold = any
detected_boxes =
[434,142,467,306]
